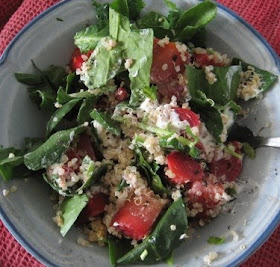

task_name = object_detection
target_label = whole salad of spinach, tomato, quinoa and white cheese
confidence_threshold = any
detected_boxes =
[0,0,277,265]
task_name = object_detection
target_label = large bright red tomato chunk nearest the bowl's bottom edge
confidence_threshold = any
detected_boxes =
[111,194,165,240]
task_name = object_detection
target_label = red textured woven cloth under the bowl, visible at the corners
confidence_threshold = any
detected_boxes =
[0,0,280,267]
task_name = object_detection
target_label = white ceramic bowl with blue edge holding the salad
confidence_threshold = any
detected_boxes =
[0,0,280,266]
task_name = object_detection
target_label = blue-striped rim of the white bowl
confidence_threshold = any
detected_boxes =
[0,0,280,266]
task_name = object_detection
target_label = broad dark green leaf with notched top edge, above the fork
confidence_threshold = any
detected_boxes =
[186,66,241,105]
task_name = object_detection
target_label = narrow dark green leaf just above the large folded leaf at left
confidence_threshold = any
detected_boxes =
[47,99,81,136]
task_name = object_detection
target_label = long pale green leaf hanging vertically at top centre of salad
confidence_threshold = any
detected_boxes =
[109,8,153,106]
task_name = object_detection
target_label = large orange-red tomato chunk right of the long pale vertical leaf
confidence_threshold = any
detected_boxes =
[151,38,189,84]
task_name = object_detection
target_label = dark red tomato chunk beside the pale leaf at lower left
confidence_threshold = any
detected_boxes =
[77,193,109,224]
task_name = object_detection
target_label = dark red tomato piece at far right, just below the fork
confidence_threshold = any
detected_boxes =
[210,142,242,181]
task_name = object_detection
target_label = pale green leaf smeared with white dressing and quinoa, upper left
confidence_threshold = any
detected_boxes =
[80,37,123,89]
